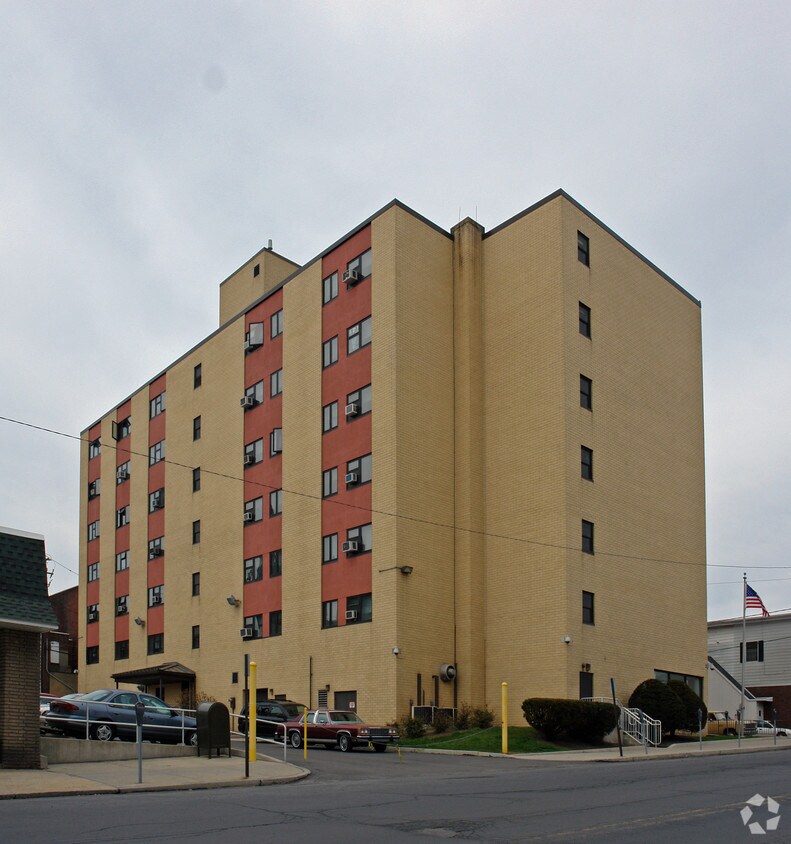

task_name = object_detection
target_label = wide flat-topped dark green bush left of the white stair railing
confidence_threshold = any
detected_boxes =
[522,697,618,744]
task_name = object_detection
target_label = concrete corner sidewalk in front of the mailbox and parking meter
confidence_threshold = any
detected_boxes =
[0,756,310,800]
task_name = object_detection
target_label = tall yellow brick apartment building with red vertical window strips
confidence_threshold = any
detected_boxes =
[79,191,706,723]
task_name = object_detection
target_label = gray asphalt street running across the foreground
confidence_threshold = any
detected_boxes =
[0,750,791,844]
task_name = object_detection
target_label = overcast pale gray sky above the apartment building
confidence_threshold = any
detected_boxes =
[0,0,791,618]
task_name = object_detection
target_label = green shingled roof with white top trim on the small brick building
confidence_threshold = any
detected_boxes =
[0,528,58,630]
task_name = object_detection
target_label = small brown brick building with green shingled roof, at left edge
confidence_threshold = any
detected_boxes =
[0,527,57,768]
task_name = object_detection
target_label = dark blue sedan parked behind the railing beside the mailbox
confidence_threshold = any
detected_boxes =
[46,689,198,745]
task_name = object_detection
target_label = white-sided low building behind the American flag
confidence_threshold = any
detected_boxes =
[709,613,791,726]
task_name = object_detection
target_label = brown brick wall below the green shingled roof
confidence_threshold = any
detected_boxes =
[0,630,41,768]
